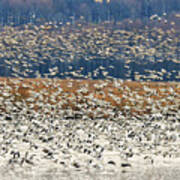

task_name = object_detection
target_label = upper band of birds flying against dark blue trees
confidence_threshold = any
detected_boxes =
[0,22,180,81]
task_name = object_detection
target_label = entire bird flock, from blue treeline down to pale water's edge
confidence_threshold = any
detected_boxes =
[0,17,180,177]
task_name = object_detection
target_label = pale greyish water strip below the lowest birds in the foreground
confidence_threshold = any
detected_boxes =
[0,166,180,180]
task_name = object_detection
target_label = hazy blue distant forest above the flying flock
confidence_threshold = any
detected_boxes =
[0,0,180,25]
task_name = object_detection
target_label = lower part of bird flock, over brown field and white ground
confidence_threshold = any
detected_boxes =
[0,78,180,173]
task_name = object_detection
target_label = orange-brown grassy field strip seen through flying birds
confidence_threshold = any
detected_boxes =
[0,78,180,118]
